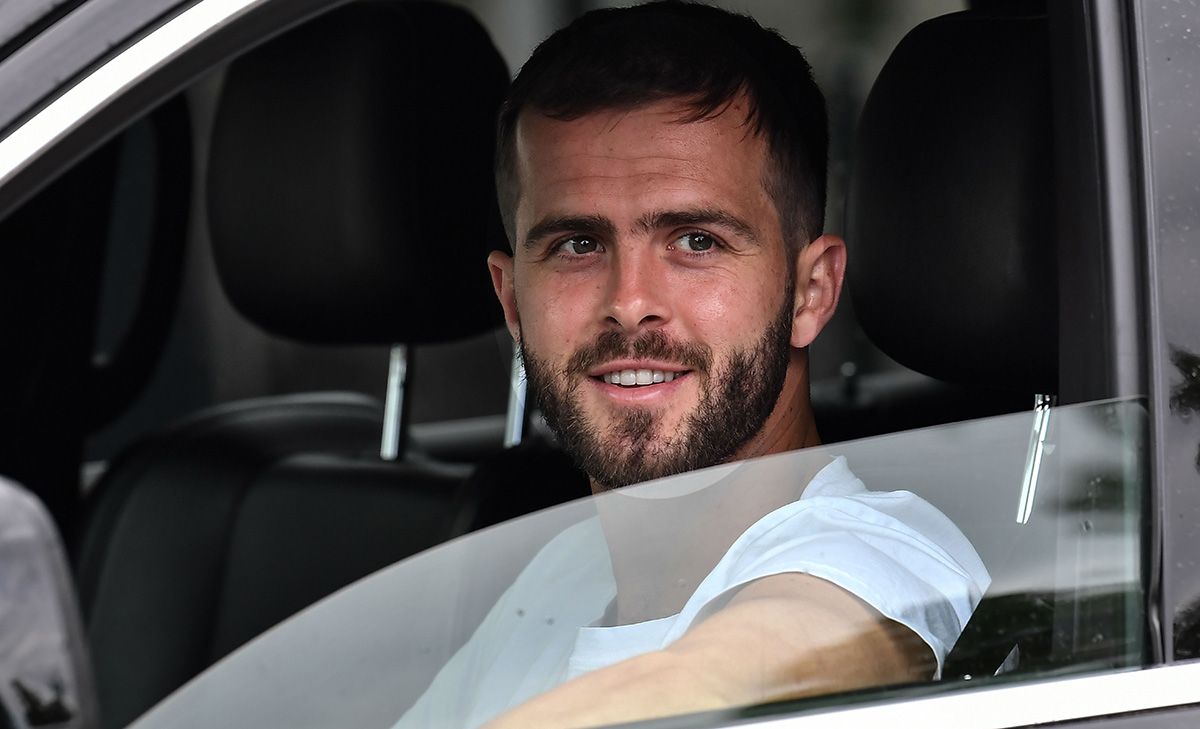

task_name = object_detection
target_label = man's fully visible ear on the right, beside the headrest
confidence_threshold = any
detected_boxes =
[792,235,846,349]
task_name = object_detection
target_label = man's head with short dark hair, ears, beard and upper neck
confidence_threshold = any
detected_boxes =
[490,6,846,496]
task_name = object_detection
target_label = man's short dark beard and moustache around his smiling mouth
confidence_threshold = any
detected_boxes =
[517,285,793,490]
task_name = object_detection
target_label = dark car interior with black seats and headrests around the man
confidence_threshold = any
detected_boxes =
[0,0,1137,727]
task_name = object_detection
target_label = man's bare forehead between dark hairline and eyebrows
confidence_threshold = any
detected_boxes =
[516,97,767,229]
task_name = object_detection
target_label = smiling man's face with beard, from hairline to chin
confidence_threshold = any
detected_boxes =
[492,100,808,488]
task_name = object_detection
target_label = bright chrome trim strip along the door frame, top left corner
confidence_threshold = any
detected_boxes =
[0,0,266,186]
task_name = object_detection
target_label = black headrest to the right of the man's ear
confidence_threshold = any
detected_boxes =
[846,11,1058,393]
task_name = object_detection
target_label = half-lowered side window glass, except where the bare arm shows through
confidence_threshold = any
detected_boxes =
[126,400,1145,729]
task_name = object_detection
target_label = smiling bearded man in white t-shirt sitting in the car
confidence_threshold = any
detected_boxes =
[393,2,988,727]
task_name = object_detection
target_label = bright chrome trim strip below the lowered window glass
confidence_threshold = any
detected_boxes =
[754,662,1200,729]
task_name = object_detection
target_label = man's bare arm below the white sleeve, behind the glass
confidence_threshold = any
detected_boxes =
[488,573,936,729]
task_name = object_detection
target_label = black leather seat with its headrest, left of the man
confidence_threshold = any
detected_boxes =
[78,1,508,727]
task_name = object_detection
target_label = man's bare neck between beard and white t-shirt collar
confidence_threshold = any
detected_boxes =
[593,350,828,625]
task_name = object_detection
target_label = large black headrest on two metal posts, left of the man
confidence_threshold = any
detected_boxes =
[208,1,509,344]
